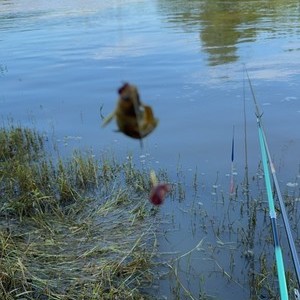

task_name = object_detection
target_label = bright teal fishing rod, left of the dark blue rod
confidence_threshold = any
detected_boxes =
[245,67,289,300]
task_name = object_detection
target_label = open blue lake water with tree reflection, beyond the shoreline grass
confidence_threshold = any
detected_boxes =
[0,0,300,299]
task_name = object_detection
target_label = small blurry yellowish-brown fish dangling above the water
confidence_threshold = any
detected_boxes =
[102,83,158,139]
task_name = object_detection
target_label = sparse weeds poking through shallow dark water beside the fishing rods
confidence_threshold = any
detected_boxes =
[161,158,300,300]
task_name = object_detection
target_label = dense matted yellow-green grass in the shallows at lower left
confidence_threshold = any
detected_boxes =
[0,126,156,299]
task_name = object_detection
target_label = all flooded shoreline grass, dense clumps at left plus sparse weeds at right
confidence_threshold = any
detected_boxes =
[0,126,300,300]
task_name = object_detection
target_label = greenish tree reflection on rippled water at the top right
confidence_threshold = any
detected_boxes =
[159,0,300,65]
